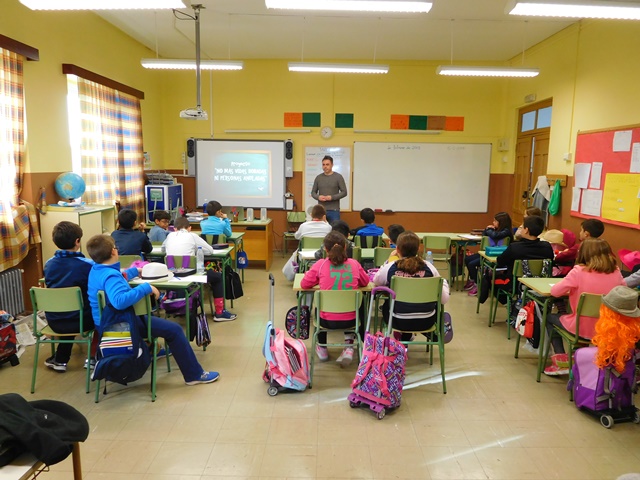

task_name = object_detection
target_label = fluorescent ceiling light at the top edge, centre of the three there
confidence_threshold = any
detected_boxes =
[265,0,433,13]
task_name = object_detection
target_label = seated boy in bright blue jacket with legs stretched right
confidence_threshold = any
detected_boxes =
[87,235,220,385]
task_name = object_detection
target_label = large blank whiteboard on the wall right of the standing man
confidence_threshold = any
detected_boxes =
[352,142,491,213]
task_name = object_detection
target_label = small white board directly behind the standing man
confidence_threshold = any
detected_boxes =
[304,147,351,212]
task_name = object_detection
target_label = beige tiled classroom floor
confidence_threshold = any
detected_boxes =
[5,258,640,480]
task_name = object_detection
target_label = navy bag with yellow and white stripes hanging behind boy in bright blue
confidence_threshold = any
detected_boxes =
[91,299,151,386]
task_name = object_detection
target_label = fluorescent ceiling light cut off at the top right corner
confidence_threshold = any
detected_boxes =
[506,0,640,20]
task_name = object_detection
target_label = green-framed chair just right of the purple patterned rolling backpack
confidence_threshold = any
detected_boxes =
[389,275,447,393]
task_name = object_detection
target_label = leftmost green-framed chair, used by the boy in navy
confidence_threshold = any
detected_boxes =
[29,287,93,393]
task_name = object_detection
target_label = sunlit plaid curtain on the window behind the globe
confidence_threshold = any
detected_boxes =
[76,77,144,219]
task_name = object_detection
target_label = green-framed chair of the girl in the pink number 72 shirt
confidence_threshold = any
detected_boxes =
[309,290,362,388]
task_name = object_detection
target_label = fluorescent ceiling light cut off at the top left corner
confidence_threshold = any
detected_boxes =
[20,0,188,10]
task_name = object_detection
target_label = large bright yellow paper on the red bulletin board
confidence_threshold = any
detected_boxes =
[602,173,640,224]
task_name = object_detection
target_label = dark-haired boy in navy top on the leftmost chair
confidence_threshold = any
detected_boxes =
[44,222,98,373]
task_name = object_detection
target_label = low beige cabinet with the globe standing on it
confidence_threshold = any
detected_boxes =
[40,205,116,262]
